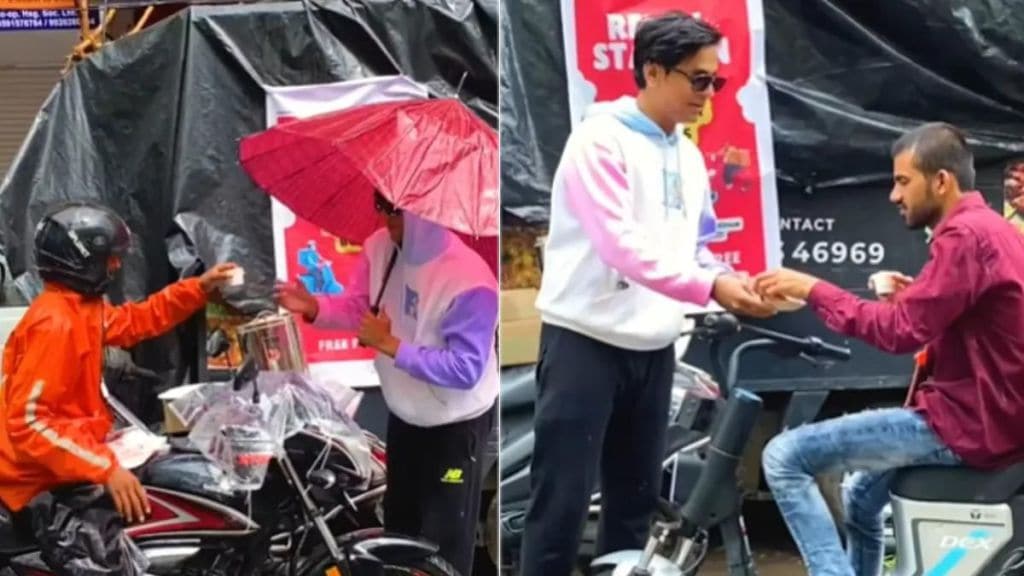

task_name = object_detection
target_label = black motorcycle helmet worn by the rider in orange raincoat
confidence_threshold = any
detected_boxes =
[36,202,131,296]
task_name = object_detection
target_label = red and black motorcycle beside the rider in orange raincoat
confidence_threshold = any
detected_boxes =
[0,342,457,576]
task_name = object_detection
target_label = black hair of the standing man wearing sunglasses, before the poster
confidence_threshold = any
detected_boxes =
[633,10,722,88]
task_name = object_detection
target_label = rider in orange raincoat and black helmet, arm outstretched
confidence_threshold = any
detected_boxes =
[0,198,234,523]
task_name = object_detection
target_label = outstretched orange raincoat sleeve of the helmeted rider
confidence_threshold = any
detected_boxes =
[103,278,207,348]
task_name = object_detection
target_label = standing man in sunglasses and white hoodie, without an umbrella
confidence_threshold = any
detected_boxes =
[521,12,774,576]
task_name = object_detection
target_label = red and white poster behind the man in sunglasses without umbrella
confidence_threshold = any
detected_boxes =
[561,0,782,275]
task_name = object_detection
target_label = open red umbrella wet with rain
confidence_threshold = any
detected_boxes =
[240,98,499,242]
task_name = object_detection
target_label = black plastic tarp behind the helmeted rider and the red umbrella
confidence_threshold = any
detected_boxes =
[0,0,498,407]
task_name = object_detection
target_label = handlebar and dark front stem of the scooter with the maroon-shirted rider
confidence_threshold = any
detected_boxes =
[591,314,850,576]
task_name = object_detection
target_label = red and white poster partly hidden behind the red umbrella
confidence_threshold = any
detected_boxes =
[264,76,428,387]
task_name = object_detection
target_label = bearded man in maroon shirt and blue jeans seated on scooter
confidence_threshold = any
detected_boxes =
[755,124,1024,576]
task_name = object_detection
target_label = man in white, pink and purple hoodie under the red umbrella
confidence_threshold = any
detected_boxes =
[278,194,498,576]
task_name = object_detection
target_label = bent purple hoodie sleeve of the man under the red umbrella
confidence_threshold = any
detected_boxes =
[394,287,498,390]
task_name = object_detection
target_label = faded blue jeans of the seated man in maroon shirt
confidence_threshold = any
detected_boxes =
[762,408,959,576]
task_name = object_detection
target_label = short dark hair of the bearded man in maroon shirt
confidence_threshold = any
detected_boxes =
[892,122,974,191]
